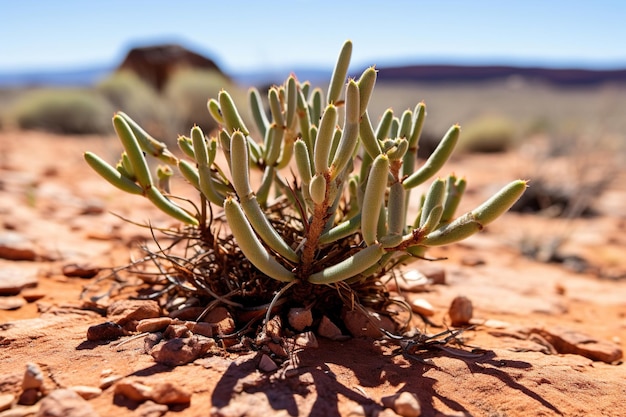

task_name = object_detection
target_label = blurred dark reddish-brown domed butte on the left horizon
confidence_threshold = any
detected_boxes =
[117,44,229,91]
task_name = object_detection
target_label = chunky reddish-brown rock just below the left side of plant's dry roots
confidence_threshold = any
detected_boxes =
[150,335,215,366]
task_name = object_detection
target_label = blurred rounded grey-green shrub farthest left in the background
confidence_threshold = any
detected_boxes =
[10,89,113,135]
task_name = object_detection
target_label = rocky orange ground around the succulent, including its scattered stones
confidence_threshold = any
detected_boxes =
[0,132,626,417]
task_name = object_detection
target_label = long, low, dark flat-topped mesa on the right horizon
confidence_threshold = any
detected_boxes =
[378,65,626,86]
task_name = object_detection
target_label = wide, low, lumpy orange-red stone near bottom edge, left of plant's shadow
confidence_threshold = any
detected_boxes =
[115,379,191,404]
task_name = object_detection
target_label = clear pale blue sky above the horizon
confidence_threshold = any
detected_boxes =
[0,0,626,72]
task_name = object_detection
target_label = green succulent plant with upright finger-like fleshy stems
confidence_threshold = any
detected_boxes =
[85,41,526,334]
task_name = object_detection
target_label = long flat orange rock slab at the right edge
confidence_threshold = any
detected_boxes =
[531,326,623,363]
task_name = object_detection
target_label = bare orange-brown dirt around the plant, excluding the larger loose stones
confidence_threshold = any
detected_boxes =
[0,132,626,417]
